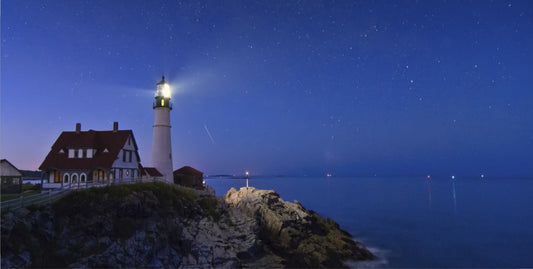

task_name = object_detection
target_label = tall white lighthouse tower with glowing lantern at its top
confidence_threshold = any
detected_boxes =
[152,76,174,183]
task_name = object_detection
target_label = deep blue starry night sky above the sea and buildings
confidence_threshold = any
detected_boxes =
[0,0,533,177]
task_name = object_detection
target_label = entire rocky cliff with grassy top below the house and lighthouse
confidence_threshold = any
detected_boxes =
[1,183,373,268]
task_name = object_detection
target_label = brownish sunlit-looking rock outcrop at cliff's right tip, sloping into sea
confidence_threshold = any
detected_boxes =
[224,187,373,267]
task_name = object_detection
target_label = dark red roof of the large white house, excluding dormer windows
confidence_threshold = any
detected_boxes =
[39,130,140,170]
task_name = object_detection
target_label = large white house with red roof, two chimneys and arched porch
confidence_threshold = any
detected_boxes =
[39,122,142,188]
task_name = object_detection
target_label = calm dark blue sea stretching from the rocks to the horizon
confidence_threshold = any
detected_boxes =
[206,177,533,268]
